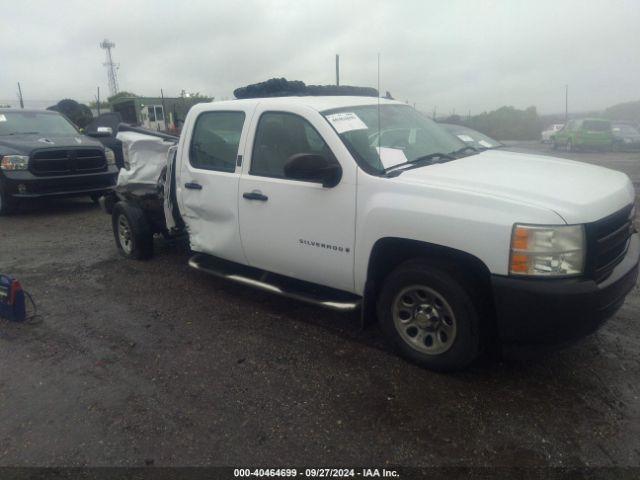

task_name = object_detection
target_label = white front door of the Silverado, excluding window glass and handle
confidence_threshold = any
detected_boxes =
[240,103,357,291]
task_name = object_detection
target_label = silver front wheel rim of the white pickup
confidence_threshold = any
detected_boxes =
[392,285,458,355]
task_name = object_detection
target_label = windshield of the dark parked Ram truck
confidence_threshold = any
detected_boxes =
[0,110,78,136]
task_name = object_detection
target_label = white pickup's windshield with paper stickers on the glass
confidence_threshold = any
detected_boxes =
[322,104,470,174]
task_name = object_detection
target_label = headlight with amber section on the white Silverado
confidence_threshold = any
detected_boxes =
[509,224,585,277]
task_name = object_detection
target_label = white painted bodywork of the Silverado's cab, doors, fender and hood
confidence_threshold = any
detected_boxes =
[170,97,635,294]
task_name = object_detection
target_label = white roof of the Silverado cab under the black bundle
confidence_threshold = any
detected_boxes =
[201,95,405,112]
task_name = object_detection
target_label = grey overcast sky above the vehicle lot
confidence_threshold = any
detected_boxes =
[0,0,640,114]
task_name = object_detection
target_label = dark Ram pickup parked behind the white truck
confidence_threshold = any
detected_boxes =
[0,109,118,215]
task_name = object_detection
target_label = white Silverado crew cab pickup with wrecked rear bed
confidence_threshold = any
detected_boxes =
[105,97,640,370]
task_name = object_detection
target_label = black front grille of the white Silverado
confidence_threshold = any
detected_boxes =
[585,205,633,283]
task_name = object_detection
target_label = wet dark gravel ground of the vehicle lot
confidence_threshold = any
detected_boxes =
[0,144,640,466]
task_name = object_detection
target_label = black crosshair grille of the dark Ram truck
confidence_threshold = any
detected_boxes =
[29,148,107,176]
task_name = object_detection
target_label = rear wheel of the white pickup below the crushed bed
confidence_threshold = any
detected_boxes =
[111,202,153,260]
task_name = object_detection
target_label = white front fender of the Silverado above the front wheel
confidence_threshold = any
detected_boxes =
[355,167,564,294]
